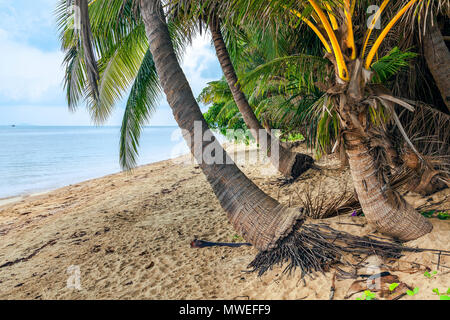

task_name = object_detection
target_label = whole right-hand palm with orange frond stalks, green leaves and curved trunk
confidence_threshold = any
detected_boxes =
[192,0,432,240]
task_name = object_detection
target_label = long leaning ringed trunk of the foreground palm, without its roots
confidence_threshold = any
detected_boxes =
[141,0,302,251]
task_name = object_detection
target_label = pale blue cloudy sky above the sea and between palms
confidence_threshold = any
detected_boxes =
[0,0,222,126]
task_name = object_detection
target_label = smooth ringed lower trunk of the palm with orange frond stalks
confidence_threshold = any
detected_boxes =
[344,132,433,241]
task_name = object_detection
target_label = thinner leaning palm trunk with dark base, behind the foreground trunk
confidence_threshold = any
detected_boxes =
[209,19,314,178]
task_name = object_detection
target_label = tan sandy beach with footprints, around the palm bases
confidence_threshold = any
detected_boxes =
[0,147,450,300]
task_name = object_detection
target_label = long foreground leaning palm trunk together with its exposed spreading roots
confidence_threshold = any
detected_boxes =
[141,0,428,276]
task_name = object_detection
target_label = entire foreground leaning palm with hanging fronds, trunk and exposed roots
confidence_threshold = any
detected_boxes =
[59,0,436,274]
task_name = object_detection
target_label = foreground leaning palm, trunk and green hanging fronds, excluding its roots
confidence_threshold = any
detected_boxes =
[58,0,303,251]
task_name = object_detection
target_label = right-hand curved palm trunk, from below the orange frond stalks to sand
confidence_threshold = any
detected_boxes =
[340,60,433,241]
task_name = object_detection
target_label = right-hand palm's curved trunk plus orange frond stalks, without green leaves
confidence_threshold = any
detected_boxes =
[298,0,432,240]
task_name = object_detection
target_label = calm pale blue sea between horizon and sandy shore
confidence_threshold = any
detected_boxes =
[0,126,195,199]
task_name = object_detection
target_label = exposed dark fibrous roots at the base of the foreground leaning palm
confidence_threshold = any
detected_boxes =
[248,222,427,278]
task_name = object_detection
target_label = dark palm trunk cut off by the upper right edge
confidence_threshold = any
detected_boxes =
[423,18,450,111]
